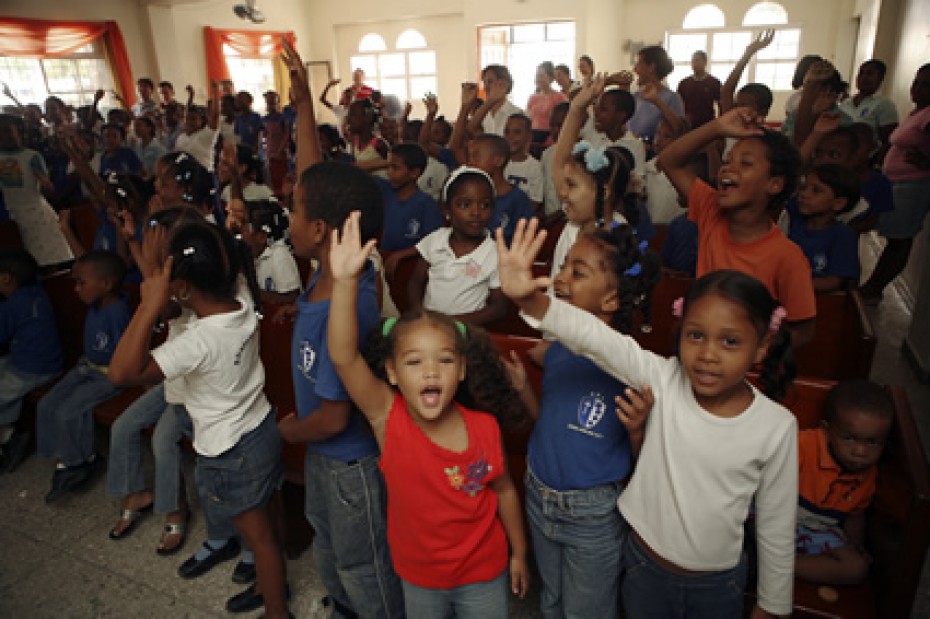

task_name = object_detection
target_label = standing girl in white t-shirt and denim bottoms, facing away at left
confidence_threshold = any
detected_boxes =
[110,222,288,618]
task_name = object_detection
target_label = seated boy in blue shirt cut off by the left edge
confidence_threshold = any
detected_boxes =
[0,249,62,472]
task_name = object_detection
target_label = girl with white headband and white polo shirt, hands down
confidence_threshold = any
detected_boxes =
[407,167,508,325]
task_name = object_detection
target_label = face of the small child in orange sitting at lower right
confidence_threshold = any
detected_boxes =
[826,409,891,473]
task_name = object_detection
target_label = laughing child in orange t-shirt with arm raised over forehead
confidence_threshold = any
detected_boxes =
[658,108,817,347]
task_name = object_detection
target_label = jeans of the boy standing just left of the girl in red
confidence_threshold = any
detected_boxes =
[305,449,404,619]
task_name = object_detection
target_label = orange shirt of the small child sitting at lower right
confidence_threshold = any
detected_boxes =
[798,428,877,529]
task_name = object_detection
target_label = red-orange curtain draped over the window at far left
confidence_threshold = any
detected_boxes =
[0,17,136,105]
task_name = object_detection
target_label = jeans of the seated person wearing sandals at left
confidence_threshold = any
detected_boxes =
[107,384,190,514]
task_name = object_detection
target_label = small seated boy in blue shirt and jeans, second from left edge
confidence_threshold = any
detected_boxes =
[36,250,132,503]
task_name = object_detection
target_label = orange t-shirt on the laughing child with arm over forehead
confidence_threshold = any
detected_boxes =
[688,180,817,320]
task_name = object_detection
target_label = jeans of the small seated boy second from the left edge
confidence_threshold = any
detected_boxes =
[36,359,121,466]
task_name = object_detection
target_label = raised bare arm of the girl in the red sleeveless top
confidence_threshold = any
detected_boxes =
[327,211,394,444]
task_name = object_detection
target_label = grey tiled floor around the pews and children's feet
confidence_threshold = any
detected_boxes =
[0,245,930,619]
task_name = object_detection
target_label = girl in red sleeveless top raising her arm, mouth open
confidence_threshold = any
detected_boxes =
[328,212,529,617]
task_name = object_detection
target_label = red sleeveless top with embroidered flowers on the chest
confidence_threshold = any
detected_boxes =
[380,394,508,589]
